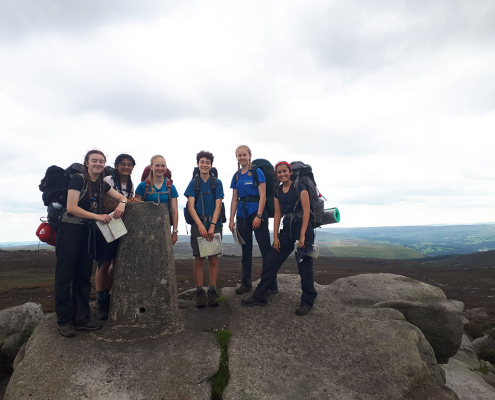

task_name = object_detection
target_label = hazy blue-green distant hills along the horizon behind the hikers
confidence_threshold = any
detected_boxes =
[0,224,495,259]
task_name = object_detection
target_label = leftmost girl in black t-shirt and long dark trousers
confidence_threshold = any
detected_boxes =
[55,150,127,337]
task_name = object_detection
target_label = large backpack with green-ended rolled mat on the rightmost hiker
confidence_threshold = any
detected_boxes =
[277,161,340,228]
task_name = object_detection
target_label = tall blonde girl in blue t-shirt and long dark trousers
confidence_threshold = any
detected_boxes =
[229,145,278,295]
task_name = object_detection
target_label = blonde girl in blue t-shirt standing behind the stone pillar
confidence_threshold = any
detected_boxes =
[136,155,179,244]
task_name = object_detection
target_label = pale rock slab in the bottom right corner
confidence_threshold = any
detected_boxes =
[442,358,495,400]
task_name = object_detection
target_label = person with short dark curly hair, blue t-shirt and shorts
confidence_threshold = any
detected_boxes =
[184,151,223,308]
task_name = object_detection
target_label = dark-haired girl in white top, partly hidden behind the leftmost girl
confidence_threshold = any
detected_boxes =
[95,154,136,319]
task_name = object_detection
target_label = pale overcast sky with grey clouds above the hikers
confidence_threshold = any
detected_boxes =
[0,0,495,242]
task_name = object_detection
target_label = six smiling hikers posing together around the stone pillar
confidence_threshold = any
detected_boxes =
[55,145,317,337]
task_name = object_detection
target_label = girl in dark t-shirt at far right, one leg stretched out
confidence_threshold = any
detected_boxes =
[241,161,317,315]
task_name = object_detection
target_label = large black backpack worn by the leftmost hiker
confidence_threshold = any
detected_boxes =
[39,163,88,229]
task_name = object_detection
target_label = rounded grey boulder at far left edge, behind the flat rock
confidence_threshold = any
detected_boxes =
[0,303,44,340]
